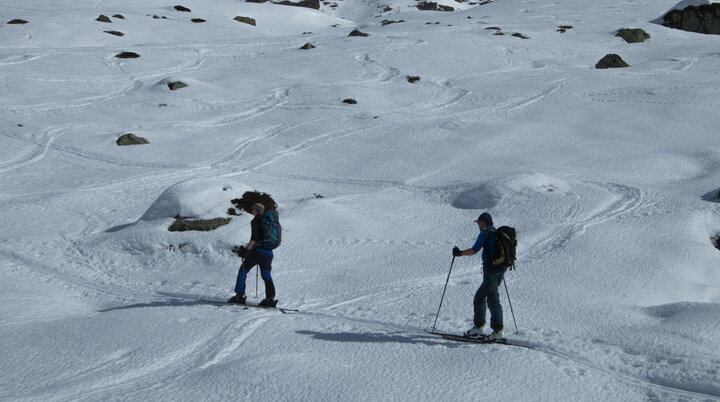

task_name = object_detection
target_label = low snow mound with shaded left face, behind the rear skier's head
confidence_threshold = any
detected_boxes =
[452,173,570,209]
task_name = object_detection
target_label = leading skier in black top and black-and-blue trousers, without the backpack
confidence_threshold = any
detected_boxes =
[228,204,277,307]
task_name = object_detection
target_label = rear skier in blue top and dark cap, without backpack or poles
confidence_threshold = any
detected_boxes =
[453,212,505,340]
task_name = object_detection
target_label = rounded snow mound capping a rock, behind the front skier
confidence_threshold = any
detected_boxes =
[140,178,252,221]
